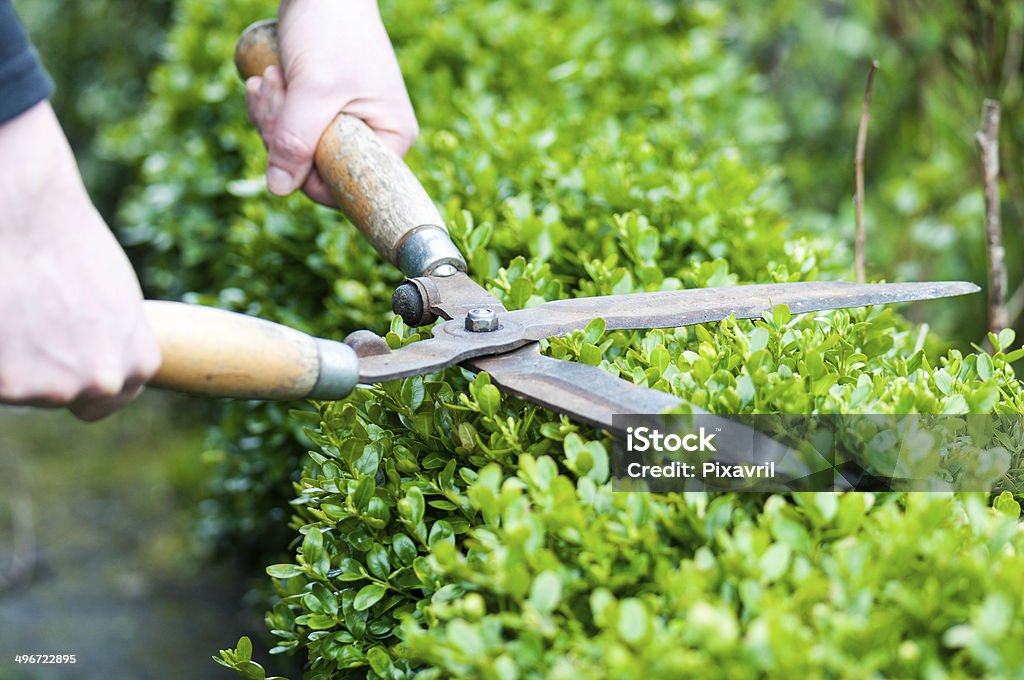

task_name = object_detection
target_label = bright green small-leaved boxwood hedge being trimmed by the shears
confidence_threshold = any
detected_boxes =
[108,0,1024,678]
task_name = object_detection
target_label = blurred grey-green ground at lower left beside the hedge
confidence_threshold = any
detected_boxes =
[0,392,278,680]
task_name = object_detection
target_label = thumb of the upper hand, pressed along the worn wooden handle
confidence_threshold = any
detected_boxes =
[266,82,339,196]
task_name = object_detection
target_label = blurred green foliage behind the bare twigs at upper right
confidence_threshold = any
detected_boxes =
[728,0,1024,342]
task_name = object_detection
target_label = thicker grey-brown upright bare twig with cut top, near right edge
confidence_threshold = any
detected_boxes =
[975,99,1008,333]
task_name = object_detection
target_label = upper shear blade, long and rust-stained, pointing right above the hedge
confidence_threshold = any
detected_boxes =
[502,281,981,340]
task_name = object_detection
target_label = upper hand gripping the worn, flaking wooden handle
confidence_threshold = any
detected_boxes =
[246,0,419,206]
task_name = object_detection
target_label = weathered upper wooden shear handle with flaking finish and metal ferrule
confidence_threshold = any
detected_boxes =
[234,19,466,277]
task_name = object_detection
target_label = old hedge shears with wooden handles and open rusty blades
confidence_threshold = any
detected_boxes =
[145,19,979,431]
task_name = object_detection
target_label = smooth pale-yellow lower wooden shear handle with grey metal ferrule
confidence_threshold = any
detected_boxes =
[143,300,358,399]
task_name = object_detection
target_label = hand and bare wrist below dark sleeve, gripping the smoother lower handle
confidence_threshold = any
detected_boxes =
[0,101,161,420]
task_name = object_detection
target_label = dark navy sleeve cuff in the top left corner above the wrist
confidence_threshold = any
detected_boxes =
[0,0,53,123]
